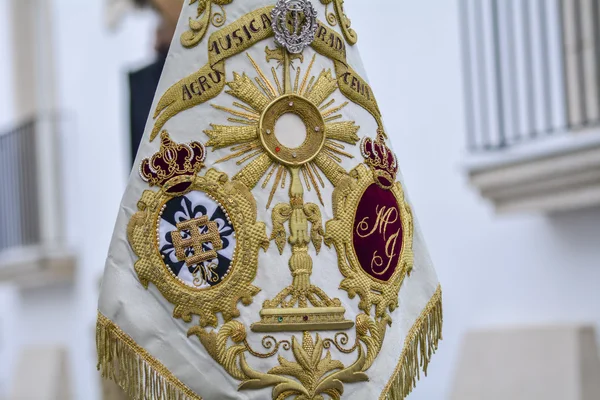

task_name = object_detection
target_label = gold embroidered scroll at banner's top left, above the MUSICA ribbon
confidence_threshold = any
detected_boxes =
[181,0,233,47]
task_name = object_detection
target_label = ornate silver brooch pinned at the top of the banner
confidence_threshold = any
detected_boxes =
[271,0,318,54]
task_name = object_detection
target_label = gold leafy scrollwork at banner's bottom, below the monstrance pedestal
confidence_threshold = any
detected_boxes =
[188,314,389,400]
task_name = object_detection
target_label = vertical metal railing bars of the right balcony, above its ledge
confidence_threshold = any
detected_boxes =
[459,0,600,152]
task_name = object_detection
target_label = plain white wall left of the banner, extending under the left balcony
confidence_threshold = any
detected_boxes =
[0,0,156,400]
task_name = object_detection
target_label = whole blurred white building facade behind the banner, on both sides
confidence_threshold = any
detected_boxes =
[0,0,600,400]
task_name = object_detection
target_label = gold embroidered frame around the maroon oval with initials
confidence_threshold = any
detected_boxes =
[325,164,414,318]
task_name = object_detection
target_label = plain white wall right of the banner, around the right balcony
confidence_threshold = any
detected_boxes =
[345,0,600,400]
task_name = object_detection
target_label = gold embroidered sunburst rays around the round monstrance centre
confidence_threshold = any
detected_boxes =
[205,48,359,209]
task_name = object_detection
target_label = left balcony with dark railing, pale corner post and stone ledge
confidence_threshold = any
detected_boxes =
[0,117,76,287]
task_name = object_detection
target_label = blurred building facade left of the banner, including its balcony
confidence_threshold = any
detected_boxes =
[0,0,157,400]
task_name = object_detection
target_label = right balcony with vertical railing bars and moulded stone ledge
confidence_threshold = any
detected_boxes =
[459,0,600,212]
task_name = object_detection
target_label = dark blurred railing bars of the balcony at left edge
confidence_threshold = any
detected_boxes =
[0,120,41,250]
